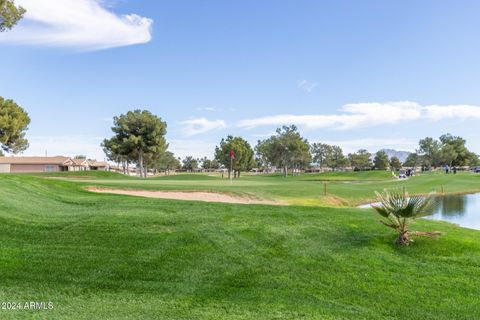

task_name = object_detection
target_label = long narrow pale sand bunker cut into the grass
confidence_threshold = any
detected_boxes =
[86,187,287,206]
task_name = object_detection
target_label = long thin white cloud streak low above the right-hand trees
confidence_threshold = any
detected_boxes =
[237,101,480,130]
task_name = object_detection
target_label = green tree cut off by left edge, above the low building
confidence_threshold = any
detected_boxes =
[0,97,30,154]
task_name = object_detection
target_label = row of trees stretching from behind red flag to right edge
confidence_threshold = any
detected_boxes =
[208,129,480,177]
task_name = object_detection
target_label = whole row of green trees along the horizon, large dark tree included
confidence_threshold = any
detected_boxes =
[102,110,479,178]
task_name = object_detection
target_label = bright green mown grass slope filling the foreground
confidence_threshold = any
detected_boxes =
[0,175,480,319]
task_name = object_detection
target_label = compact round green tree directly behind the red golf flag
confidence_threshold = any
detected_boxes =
[215,136,255,178]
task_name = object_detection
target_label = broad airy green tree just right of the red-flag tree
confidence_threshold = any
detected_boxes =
[255,125,312,176]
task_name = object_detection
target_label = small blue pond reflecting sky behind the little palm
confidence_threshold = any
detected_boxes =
[360,193,480,230]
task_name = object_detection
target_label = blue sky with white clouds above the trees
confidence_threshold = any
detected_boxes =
[0,0,480,159]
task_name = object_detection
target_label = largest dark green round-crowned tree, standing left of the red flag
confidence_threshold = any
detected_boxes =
[104,110,168,177]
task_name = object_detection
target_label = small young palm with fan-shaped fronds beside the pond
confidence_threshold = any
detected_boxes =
[373,190,440,246]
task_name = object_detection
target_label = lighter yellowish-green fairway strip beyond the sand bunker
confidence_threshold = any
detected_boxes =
[52,171,480,206]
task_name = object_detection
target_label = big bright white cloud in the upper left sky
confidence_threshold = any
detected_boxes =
[0,0,153,50]
